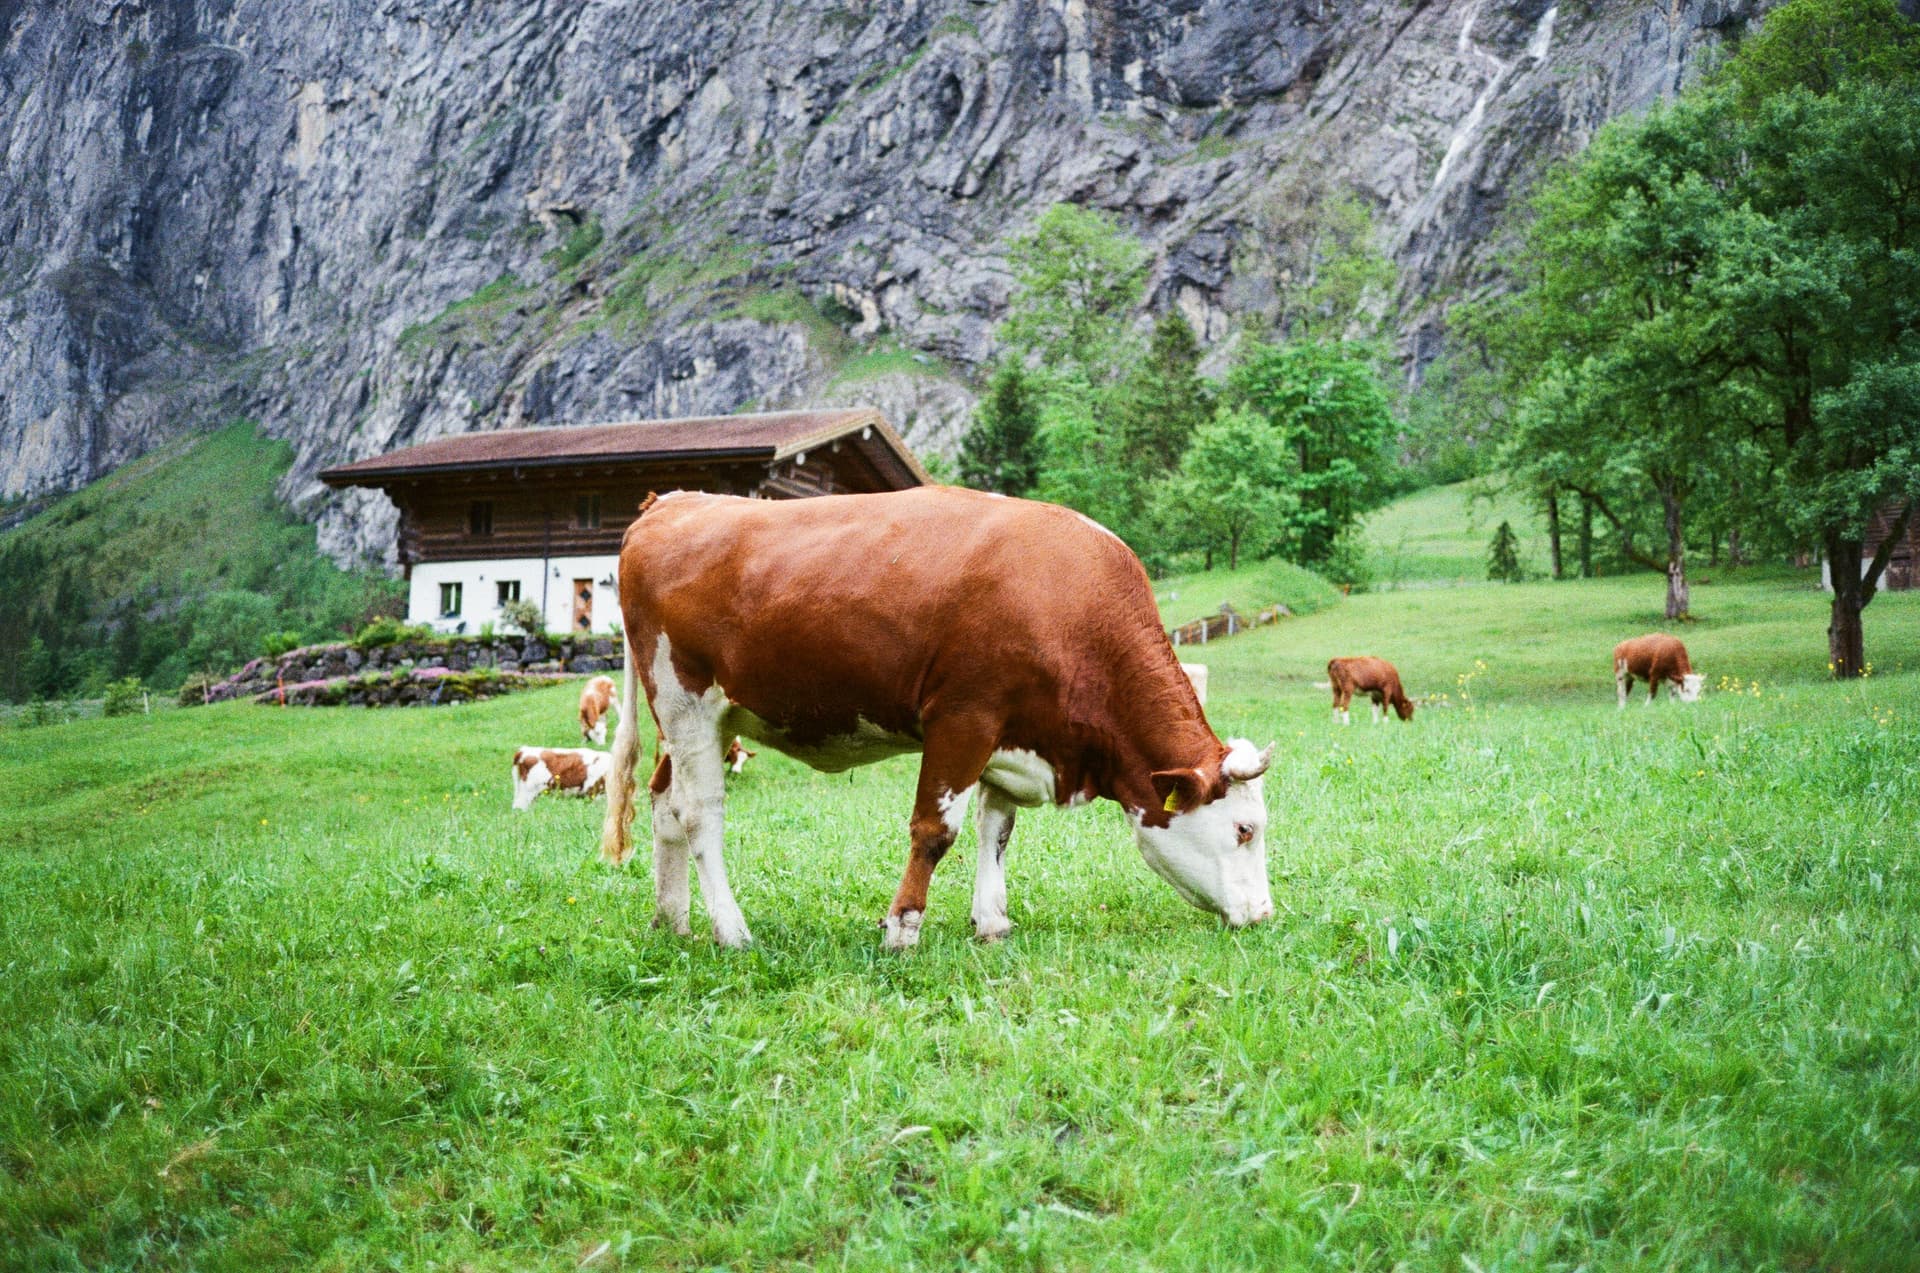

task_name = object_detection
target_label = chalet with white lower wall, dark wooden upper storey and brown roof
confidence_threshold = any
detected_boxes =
[321,407,931,632]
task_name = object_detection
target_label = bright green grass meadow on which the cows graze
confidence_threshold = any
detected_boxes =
[0,556,1920,1271]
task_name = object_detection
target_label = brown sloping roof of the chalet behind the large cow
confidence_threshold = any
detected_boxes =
[319,407,933,486]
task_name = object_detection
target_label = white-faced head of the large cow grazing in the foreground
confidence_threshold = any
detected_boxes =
[1135,737,1273,927]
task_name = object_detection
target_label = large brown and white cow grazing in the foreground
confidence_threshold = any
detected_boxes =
[601,486,1273,949]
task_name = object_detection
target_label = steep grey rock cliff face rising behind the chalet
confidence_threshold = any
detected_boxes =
[0,0,1766,559]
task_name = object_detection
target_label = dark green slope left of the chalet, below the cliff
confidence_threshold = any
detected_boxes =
[0,422,403,703]
